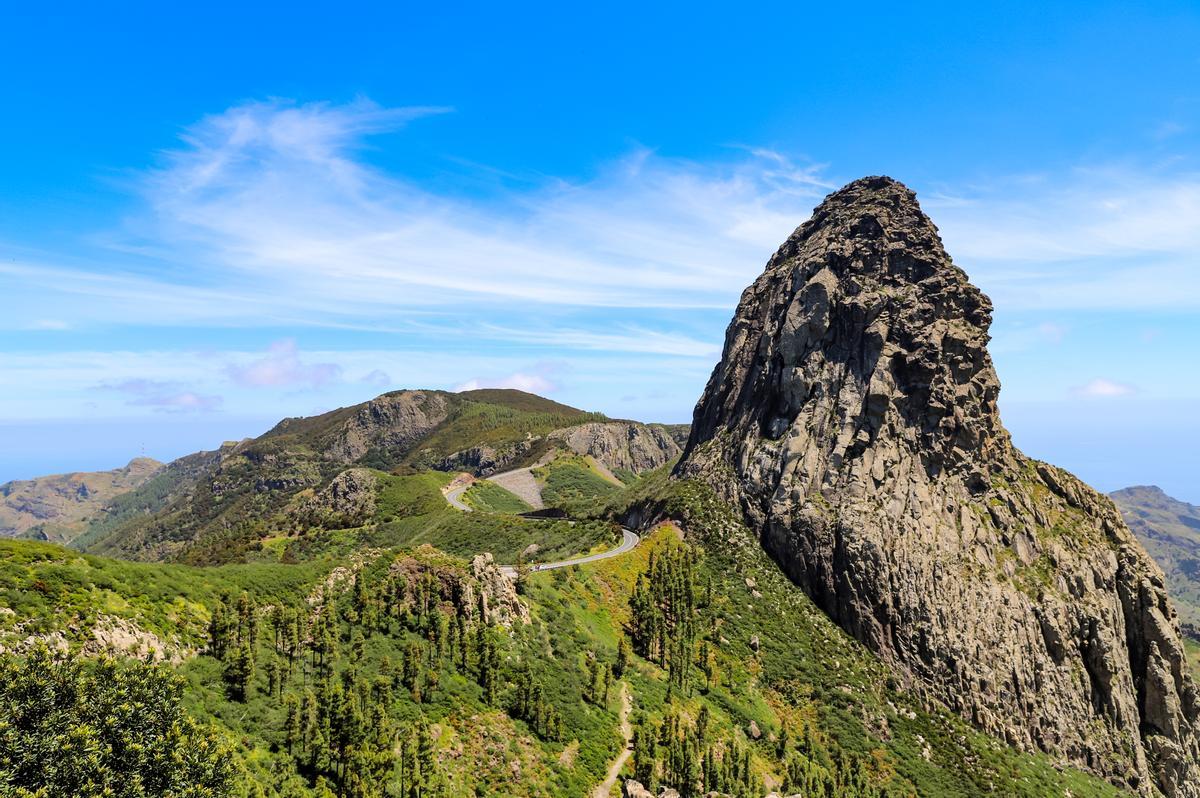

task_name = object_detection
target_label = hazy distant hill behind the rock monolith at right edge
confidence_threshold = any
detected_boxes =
[1109,485,1200,638]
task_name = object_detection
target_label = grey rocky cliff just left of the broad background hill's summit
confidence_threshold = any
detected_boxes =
[325,391,450,463]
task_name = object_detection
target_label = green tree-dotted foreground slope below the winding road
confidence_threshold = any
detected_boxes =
[0,474,1132,798]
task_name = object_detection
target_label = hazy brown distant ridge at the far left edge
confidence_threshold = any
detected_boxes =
[0,457,163,542]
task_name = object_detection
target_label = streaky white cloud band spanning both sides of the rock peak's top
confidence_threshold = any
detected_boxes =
[9,101,1200,338]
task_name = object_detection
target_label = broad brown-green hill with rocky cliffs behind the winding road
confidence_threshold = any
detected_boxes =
[76,390,679,564]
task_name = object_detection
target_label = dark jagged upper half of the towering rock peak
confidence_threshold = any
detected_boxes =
[689,178,1008,486]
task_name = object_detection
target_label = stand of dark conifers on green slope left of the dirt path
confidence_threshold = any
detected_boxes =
[201,554,612,798]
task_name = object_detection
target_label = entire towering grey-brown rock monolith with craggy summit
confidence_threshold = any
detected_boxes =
[679,178,1200,797]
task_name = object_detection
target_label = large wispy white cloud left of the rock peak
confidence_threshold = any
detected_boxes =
[2,102,827,324]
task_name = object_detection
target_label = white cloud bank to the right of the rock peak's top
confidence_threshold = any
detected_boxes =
[923,166,1200,311]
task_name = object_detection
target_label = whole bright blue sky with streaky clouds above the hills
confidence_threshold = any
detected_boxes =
[0,2,1200,503]
